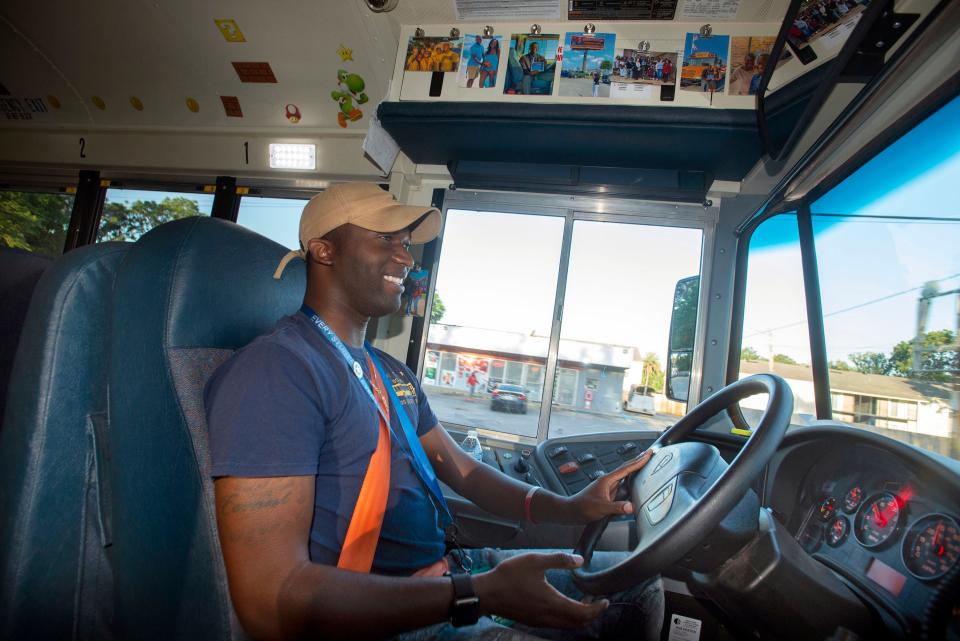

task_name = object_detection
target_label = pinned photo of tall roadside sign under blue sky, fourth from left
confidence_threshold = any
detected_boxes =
[560,32,617,98]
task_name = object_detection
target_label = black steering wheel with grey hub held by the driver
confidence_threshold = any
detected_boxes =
[573,374,793,594]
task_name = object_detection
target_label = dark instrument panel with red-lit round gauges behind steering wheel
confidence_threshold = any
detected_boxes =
[767,426,960,630]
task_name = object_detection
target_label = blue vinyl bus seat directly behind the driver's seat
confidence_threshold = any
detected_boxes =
[0,243,129,641]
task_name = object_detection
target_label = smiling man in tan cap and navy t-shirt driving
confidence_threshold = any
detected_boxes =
[205,183,663,640]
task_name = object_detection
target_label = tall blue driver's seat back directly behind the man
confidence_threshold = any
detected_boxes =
[109,217,306,641]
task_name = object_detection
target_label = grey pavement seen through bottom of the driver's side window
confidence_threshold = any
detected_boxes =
[427,386,677,437]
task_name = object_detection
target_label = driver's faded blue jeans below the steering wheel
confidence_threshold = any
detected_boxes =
[395,548,664,641]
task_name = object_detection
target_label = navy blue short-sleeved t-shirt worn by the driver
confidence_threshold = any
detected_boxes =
[204,313,444,574]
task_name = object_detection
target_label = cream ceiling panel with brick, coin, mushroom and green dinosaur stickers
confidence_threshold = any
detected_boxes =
[0,0,397,133]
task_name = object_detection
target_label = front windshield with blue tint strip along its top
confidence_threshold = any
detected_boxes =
[740,94,960,459]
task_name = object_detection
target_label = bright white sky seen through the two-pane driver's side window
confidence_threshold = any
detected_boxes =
[436,210,703,363]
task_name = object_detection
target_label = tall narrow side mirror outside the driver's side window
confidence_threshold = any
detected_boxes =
[666,276,700,403]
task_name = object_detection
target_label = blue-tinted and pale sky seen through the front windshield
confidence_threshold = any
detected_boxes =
[743,98,960,363]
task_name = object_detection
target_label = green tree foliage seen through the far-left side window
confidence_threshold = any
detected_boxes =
[0,191,73,256]
